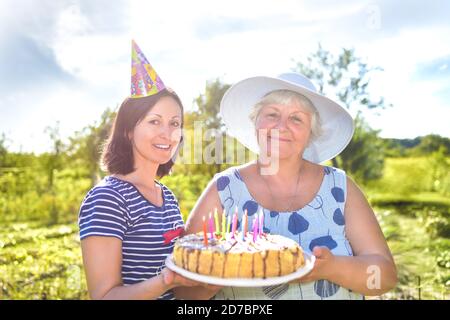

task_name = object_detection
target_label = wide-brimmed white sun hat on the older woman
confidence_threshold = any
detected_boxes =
[220,73,354,163]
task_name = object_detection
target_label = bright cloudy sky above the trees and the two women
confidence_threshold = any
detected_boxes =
[0,0,450,153]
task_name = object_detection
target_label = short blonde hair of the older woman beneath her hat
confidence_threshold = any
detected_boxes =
[249,90,322,143]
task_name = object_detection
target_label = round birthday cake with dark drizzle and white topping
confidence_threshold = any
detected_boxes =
[173,232,305,279]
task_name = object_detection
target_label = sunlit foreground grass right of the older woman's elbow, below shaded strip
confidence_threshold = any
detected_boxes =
[376,208,450,299]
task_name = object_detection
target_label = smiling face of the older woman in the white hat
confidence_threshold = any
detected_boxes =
[255,99,311,160]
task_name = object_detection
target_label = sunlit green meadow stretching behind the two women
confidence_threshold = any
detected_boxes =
[0,157,450,299]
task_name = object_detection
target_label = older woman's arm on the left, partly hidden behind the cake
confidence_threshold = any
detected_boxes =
[173,180,222,300]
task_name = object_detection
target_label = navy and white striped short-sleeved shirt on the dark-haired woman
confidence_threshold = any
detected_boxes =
[78,176,184,299]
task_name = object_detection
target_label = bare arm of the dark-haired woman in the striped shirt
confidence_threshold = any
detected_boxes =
[81,236,198,300]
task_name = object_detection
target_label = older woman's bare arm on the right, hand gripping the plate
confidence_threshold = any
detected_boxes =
[300,178,397,296]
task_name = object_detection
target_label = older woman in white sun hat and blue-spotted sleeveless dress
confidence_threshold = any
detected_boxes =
[187,73,397,299]
